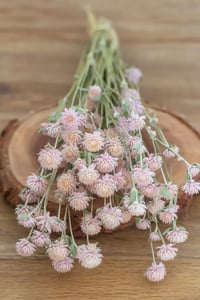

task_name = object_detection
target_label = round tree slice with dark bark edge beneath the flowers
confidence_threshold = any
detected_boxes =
[0,108,200,236]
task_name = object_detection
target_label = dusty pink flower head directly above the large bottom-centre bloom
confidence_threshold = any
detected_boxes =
[81,213,101,236]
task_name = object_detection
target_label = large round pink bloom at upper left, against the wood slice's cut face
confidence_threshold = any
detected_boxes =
[38,147,62,170]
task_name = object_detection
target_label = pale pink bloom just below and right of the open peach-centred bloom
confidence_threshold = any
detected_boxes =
[95,152,117,173]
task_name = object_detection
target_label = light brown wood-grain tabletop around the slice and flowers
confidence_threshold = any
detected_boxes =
[0,0,200,300]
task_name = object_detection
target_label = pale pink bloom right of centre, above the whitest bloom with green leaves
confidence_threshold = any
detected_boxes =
[133,168,155,187]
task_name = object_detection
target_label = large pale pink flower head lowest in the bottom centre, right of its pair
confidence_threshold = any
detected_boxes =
[77,243,103,269]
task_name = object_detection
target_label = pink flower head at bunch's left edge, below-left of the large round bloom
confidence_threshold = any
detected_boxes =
[26,173,48,195]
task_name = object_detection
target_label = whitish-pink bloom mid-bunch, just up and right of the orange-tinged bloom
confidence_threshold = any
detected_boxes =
[78,164,100,185]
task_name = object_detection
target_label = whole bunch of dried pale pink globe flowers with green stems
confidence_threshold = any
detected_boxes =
[16,15,200,282]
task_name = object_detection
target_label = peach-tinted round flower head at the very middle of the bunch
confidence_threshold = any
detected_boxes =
[94,174,117,198]
